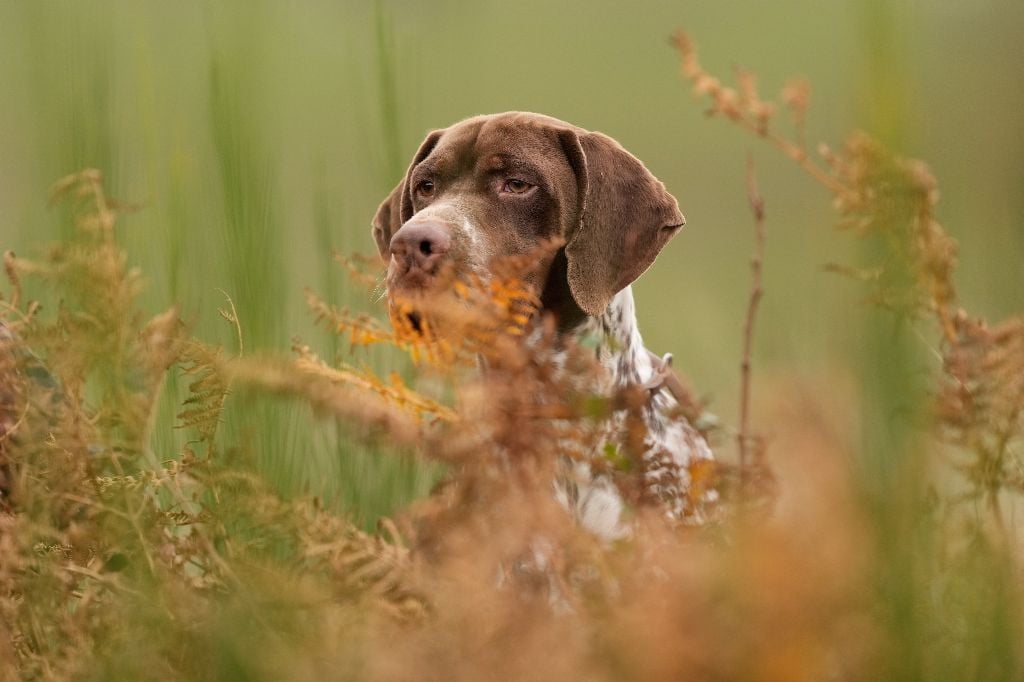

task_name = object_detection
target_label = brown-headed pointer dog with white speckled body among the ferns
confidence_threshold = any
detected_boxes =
[373,112,714,541]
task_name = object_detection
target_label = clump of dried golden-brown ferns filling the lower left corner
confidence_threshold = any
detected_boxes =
[0,171,424,679]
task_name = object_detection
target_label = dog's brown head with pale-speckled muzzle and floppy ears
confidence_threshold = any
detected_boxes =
[373,112,685,315]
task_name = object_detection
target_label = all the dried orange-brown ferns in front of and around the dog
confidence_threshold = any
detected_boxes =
[0,35,1024,680]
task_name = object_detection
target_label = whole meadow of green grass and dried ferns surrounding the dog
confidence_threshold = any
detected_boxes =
[0,0,1024,680]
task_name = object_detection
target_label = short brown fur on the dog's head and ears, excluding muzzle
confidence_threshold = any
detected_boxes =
[373,112,685,327]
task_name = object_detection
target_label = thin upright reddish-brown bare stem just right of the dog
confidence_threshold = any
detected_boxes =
[736,155,766,489]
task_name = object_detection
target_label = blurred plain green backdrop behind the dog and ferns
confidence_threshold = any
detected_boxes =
[0,0,1024,520]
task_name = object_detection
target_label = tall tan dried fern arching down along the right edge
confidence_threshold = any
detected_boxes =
[674,32,1024,527]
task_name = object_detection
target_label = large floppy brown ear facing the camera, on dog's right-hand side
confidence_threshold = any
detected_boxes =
[559,130,685,315]
